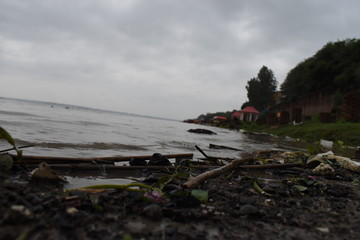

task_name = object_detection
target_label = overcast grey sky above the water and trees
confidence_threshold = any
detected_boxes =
[0,0,360,120]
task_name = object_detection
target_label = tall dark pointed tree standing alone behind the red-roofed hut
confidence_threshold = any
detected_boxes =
[243,66,277,112]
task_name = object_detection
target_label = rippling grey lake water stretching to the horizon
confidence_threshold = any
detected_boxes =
[0,98,286,186]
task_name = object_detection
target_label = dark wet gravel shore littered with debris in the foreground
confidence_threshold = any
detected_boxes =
[0,162,360,240]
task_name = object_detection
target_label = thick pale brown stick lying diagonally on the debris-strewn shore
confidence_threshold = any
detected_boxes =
[183,158,254,188]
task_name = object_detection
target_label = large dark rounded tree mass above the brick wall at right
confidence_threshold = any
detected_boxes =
[281,39,360,100]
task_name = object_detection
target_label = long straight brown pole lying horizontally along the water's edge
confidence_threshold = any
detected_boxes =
[10,153,194,164]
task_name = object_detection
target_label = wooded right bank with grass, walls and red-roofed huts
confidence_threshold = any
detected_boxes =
[185,39,360,152]
